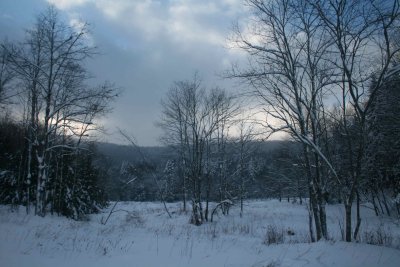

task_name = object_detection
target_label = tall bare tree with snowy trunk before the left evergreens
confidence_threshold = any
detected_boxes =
[4,7,117,216]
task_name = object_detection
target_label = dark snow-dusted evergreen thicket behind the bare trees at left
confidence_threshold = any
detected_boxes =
[0,118,108,219]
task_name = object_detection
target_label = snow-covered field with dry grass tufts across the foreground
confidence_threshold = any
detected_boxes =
[0,200,400,267]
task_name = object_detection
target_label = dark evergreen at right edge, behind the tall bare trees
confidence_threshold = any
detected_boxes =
[364,75,400,215]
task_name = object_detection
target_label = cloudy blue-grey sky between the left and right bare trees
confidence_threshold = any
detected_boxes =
[0,0,248,146]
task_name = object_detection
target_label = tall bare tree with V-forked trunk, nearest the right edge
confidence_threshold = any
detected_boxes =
[310,0,400,241]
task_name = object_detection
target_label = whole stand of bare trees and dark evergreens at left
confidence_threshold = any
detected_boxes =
[0,7,116,219]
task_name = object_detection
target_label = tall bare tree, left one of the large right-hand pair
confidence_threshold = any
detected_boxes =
[229,0,335,240]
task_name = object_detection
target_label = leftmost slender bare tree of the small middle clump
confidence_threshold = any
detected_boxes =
[160,76,208,225]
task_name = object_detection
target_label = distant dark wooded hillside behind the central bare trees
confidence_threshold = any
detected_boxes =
[94,140,307,204]
